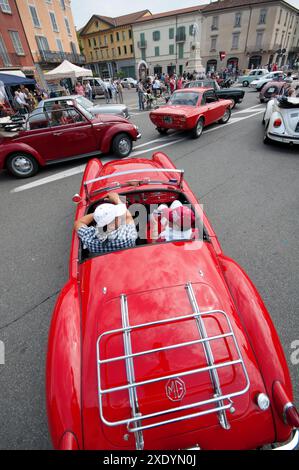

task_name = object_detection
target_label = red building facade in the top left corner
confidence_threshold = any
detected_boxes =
[0,0,34,77]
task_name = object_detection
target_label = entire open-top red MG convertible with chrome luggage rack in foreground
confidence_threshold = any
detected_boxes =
[46,153,299,450]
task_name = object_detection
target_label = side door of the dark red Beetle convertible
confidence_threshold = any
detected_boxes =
[42,107,98,161]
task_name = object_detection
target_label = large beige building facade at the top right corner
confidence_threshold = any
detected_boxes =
[201,0,299,70]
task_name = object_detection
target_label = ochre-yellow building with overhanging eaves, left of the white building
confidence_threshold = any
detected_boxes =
[79,10,151,78]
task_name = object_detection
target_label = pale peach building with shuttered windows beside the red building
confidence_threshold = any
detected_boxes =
[16,0,85,70]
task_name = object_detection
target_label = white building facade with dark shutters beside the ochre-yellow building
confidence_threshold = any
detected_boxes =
[133,6,206,77]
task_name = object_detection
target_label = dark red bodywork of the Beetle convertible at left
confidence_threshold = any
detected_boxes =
[0,111,138,170]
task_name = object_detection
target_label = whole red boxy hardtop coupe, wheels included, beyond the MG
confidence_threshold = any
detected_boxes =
[150,88,233,139]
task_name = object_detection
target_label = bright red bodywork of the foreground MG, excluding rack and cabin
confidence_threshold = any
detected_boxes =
[47,153,293,450]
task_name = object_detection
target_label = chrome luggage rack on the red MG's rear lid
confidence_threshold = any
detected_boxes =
[97,282,250,450]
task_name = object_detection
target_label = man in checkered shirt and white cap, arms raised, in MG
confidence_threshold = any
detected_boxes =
[74,193,138,253]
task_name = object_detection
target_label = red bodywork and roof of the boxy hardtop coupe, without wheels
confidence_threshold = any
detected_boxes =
[150,88,232,130]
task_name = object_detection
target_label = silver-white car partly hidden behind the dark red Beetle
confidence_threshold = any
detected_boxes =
[31,95,130,118]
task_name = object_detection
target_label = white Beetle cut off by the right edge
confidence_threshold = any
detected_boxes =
[263,96,299,145]
